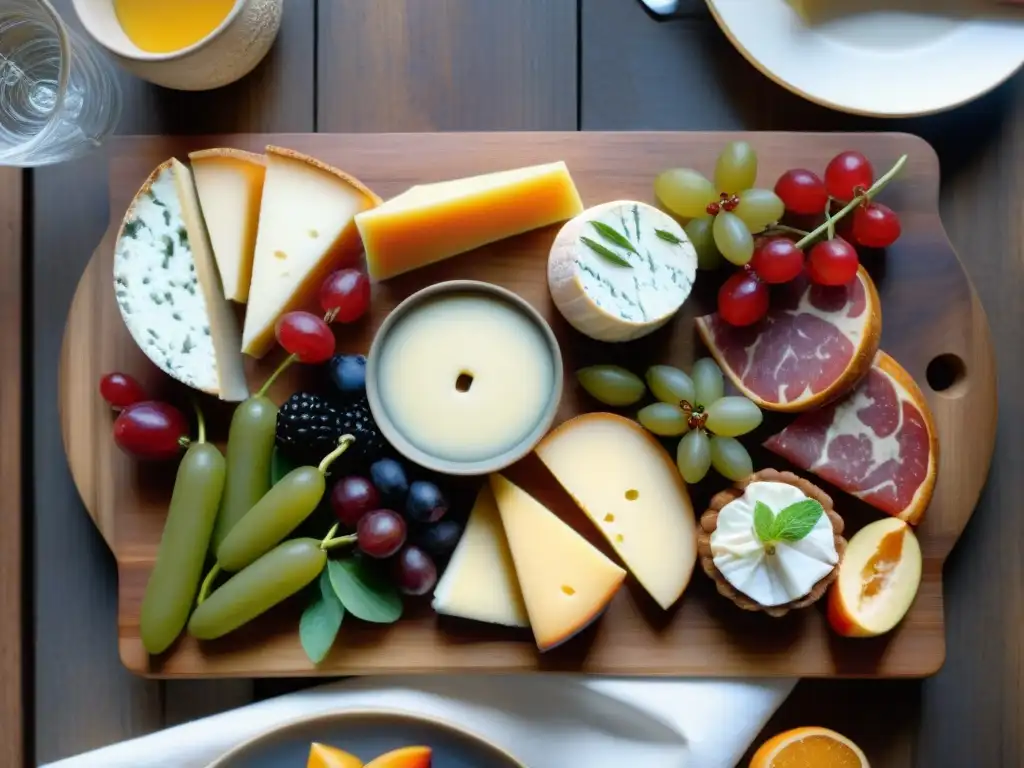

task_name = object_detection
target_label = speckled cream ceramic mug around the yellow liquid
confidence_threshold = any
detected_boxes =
[73,0,285,91]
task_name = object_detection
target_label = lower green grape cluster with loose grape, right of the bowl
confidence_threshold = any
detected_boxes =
[577,357,762,483]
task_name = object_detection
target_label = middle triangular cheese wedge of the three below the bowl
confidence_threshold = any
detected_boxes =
[490,474,626,651]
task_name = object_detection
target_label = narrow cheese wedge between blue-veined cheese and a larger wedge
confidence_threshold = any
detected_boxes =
[188,148,266,304]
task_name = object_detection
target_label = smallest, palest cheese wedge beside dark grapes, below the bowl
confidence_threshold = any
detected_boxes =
[433,484,529,627]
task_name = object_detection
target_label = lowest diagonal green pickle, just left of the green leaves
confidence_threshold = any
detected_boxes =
[188,539,327,640]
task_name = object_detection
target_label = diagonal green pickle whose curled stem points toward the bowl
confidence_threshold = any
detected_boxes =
[217,435,354,572]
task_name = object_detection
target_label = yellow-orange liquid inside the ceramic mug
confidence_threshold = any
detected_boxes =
[114,0,234,53]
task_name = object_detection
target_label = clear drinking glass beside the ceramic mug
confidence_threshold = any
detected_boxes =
[0,0,121,166]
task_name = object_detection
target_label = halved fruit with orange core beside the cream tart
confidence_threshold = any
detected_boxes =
[828,518,922,637]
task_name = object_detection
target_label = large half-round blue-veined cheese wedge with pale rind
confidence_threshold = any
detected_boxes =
[114,158,249,401]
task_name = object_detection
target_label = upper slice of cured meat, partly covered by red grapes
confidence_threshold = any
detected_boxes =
[696,267,882,411]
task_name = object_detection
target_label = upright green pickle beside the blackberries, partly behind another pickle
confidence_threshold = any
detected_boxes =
[213,393,278,551]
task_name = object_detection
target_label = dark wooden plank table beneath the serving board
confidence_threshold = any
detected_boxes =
[9,0,1024,768]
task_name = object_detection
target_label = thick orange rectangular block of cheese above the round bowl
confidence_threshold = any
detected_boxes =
[355,162,583,280]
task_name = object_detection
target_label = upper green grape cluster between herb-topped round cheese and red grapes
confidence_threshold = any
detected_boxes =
[654,141,785,269]
